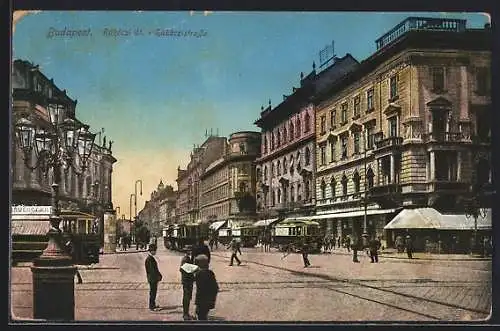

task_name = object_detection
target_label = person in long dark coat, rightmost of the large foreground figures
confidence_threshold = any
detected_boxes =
[194,254,219,321]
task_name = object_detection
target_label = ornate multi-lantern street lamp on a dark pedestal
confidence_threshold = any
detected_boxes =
[15,100,95,320]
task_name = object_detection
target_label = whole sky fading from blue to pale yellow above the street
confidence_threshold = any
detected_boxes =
[12,11,489,218]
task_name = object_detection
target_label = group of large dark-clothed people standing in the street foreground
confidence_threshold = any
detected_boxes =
[145,239,219,320]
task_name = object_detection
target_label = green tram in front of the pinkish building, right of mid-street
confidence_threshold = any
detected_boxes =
[272,218,322,253]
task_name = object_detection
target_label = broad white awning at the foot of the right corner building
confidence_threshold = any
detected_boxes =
[384,208,491,230]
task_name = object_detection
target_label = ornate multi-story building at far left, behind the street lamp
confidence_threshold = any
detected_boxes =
[11,60,116,241]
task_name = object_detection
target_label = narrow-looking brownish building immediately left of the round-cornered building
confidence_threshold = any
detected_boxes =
[175,135,226,223]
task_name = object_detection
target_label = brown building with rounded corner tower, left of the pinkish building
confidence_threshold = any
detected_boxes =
[200,131,260,225]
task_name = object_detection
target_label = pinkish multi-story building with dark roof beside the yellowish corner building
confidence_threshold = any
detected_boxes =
[255,54,358,223]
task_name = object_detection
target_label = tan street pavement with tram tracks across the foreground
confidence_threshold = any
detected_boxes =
[10,246,492,322]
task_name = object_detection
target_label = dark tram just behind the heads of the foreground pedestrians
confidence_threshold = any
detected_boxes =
[168,223,209,251]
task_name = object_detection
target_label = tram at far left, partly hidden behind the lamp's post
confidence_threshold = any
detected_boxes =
[11,210,102,265]
